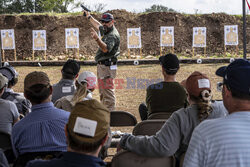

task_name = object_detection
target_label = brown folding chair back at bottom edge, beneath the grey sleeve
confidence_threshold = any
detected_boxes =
[111,151,175,167]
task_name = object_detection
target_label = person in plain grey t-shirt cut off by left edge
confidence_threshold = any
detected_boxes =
[0,73,19,135]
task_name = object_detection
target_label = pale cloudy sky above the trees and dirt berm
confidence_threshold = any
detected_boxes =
[79,0,245,14]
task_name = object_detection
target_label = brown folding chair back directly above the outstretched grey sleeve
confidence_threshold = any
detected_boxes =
[133,119,166,136]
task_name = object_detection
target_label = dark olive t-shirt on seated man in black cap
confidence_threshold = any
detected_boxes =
[146,82,187,115]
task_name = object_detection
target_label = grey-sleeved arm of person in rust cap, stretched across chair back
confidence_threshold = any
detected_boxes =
[120,113,184,157]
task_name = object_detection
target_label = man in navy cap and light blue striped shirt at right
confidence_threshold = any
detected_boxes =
[184,59,250,167]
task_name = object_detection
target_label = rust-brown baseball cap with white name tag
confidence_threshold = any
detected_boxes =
[186,71,211,97]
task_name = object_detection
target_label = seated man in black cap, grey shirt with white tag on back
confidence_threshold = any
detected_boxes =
[52,59,80,103]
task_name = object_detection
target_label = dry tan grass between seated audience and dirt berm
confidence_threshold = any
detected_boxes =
[14,64,224,121]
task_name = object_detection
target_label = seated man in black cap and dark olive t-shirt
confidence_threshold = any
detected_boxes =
[139,54,187,120]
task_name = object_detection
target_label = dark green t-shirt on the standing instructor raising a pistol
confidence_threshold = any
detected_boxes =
[95,26,120,62]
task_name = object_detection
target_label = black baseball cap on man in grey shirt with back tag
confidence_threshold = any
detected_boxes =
[62,59,80,75]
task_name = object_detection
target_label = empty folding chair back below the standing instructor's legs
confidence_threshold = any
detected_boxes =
[110,111,137,127]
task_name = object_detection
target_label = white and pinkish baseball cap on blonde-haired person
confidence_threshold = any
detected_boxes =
[77,71,96,89]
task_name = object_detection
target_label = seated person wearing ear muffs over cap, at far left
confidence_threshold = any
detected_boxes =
[0,66,31,116]
